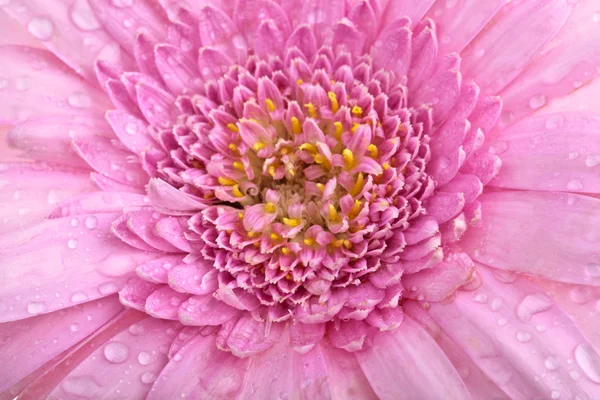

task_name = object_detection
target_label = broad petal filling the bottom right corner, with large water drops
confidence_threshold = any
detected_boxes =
[429,266,600,398]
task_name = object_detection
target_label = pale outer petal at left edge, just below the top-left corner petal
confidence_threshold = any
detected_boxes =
[0,46,110,124]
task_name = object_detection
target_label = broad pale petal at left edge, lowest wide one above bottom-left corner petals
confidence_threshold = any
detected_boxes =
[0,214,153,321]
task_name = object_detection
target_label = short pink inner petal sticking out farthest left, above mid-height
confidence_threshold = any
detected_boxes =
[73,136,148,187]
